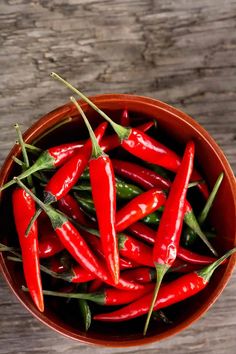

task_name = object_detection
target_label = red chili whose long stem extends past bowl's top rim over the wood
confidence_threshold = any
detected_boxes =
[51,72,206,198]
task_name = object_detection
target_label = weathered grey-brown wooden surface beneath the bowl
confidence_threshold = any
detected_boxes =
[0,0,236,354]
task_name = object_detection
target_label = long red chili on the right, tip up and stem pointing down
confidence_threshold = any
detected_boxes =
[144,141,195,335]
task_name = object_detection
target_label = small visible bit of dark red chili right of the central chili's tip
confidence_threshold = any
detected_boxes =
[122,267,156,283]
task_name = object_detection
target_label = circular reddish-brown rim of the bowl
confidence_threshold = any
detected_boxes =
[0,94,236,348]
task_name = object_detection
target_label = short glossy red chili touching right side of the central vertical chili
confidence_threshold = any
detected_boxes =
[116,188,166,232]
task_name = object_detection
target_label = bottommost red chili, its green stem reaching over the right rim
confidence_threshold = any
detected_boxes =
[93,248,236,322]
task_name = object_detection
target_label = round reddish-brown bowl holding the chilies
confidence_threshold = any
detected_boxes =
[0,94,236,347]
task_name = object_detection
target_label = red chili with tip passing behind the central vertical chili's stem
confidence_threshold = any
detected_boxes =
[44,123,107,204]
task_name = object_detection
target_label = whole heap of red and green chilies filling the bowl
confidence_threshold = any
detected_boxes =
[0,73,236,335]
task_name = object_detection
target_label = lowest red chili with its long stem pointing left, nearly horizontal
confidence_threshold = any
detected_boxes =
[33,284,154,306]
